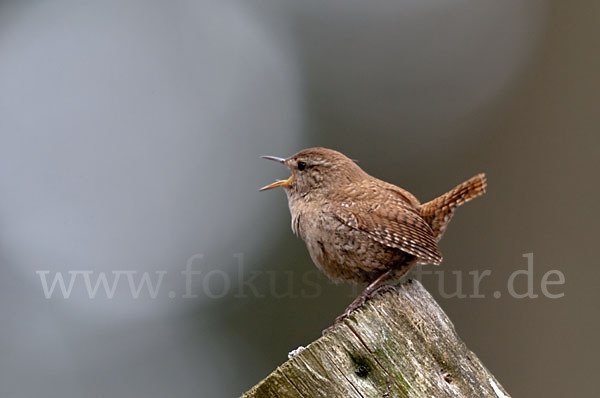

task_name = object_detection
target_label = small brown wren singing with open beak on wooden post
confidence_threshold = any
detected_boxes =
[260,148,486,323]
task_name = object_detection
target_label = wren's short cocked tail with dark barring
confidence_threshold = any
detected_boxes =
[419,173,487,241]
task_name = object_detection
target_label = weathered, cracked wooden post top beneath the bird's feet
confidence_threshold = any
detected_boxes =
[243,281,508,398]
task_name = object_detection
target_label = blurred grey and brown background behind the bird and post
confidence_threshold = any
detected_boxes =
[0,0,600,397]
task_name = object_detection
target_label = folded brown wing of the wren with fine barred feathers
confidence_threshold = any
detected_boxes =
[331,190,442,265]
